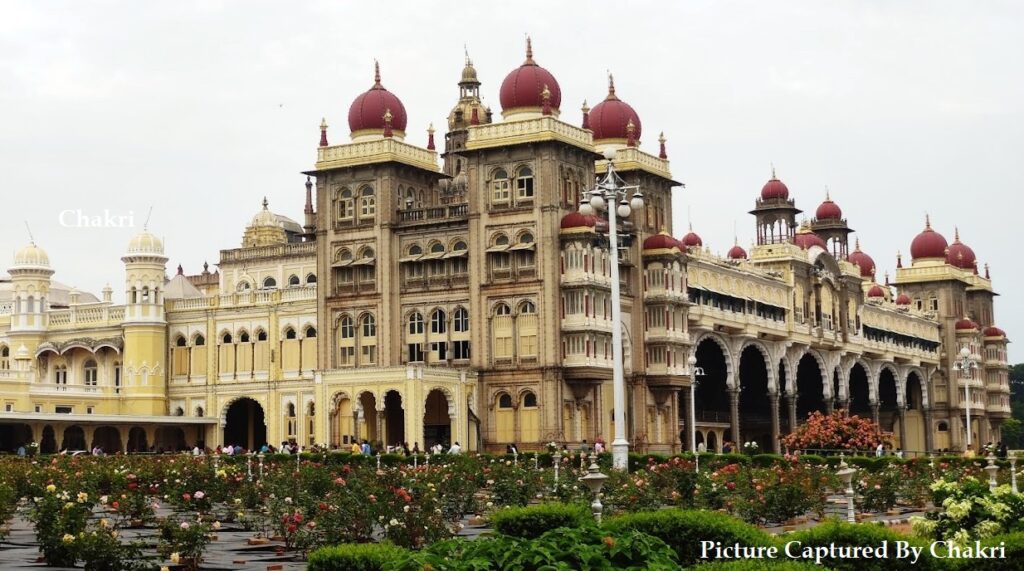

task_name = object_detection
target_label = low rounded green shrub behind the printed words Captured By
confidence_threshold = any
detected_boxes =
[779,520,947,571]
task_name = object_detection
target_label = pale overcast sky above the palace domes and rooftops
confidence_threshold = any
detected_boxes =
[0,0,1024,358]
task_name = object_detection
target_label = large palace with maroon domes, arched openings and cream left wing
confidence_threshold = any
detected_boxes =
[0,41,1010,452]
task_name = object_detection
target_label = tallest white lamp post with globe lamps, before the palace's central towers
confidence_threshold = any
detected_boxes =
[580,148,643,470]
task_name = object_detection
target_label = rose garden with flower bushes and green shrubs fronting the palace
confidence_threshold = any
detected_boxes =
[0,415,1024,571]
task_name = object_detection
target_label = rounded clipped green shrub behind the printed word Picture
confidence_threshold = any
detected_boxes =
[604,510,775,565]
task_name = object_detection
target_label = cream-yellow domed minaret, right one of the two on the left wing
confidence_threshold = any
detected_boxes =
[121,230,167,415]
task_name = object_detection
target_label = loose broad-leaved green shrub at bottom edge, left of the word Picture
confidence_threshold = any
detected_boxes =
[391,526,679,571]
